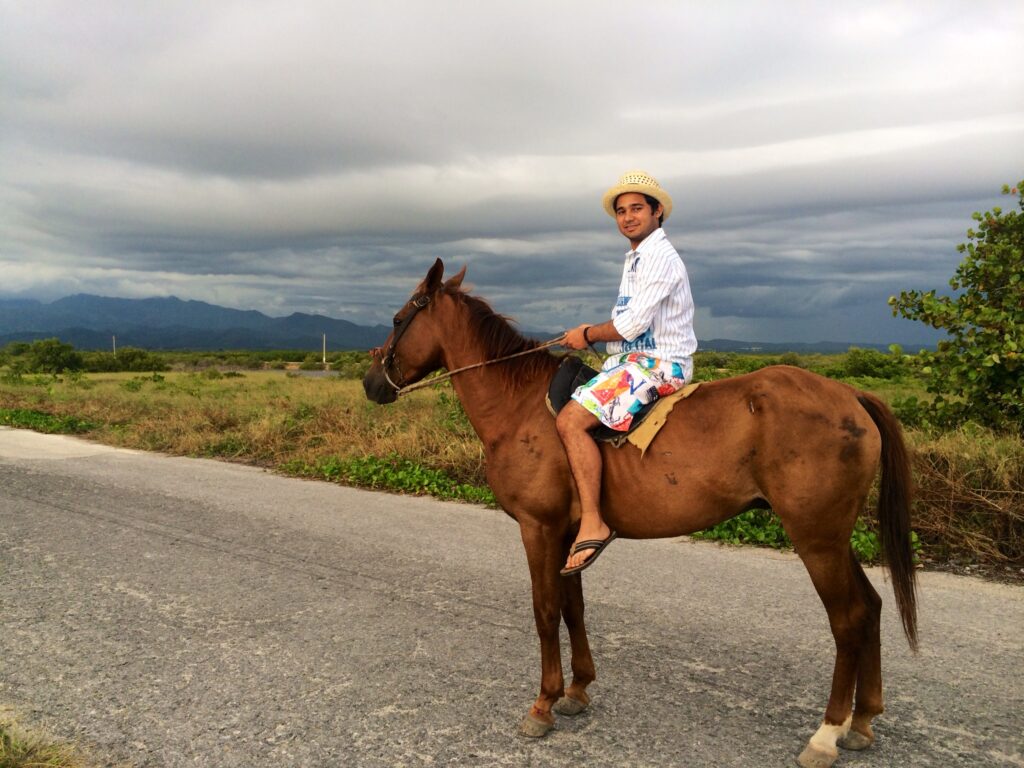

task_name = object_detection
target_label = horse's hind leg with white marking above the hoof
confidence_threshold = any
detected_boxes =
[794,541,881,768]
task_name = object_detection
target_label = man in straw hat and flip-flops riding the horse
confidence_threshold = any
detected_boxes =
[555,171,697,575]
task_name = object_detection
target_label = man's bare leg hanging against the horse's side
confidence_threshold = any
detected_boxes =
[555,400,611,568]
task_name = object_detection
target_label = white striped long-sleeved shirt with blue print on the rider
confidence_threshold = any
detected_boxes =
[607,227,697,360]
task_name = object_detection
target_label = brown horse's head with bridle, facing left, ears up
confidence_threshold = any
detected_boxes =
[362,259,466,404]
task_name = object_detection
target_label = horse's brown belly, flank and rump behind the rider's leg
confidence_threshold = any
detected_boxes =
[604,366,881,537]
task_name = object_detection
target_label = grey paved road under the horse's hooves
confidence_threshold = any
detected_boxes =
[0,429,1024,768]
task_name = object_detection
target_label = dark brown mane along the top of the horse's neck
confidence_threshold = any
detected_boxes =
[446,282,558,389]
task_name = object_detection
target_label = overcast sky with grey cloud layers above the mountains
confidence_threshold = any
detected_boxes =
[0,0,1024,343]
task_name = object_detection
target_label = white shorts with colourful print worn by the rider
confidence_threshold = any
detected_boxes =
[572,352,693,432]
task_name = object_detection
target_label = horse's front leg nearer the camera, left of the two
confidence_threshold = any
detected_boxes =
[519,520,565,737]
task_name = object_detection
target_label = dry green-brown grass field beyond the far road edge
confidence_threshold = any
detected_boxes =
[0,355,1024,566]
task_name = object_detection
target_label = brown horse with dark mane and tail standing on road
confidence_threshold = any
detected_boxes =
[364,259,916,768]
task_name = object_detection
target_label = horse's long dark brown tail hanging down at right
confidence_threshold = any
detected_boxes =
[857,392,918,650]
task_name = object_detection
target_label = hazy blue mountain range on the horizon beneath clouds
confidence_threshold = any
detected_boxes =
[0,294,887,354]
